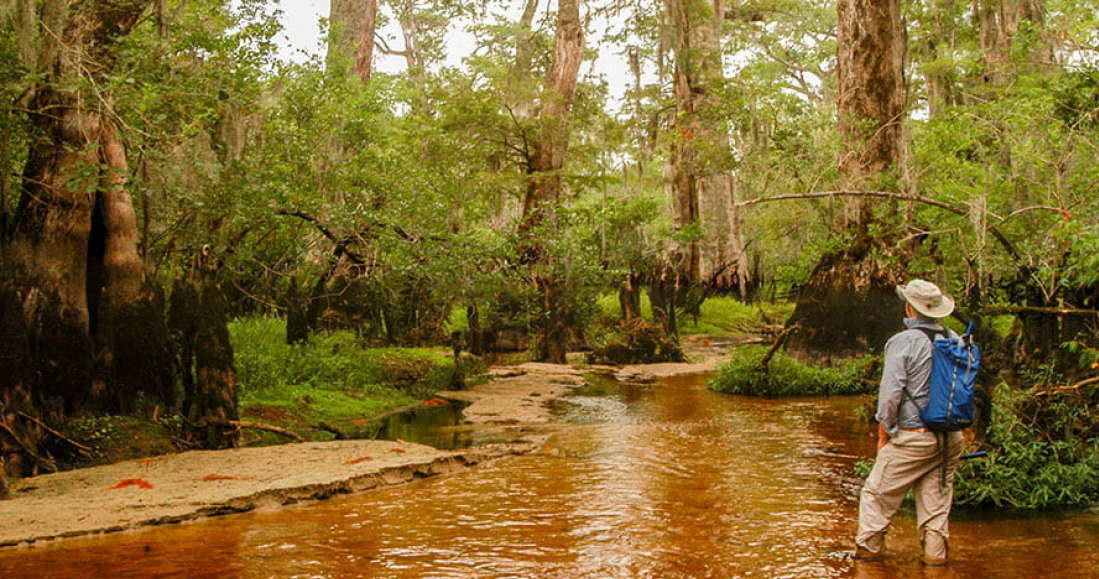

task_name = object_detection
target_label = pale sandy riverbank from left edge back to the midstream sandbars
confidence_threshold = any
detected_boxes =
[0,347,734,546]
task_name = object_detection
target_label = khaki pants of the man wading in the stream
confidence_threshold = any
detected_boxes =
[855,431,962,559]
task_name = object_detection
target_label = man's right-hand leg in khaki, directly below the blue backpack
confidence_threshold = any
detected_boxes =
[913,432,962,565]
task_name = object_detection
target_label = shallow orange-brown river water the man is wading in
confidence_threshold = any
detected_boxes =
[0,376,1099,579]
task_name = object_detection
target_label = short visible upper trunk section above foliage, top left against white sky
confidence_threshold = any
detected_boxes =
[326,0,378,82]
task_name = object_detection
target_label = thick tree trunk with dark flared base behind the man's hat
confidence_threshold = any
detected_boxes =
[787,0,906,360]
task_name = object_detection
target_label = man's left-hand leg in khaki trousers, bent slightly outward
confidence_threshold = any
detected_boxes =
[855,432,935,557]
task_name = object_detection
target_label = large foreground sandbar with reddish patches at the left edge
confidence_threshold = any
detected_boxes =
[0,441,537,546]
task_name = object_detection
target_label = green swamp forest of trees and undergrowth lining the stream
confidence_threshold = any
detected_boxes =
[0,0,1099,516]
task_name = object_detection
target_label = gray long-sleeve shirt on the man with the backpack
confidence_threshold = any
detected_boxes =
[875,318,953,436]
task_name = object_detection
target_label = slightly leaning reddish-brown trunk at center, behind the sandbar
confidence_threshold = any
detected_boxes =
[520,0,584,363]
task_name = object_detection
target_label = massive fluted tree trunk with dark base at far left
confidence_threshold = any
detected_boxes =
[0,0,179,474]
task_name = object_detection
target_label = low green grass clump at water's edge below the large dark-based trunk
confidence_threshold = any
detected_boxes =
[709,346,877,397]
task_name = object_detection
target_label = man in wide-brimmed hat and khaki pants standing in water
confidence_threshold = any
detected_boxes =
[855,279,962,566]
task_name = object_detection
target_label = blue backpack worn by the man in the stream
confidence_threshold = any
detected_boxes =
[920,322,980,432]
